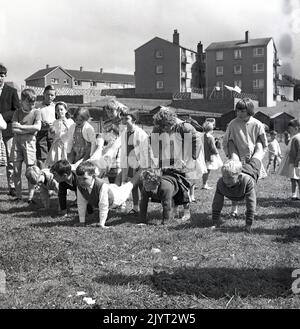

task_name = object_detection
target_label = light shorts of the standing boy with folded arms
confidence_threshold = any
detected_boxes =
[11,135,36,166]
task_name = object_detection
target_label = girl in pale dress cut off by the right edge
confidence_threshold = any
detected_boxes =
[278,119,300,200]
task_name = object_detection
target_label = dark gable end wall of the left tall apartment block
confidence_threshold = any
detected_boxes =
[135,38,181,94]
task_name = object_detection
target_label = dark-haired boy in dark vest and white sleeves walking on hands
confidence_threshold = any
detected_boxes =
[76,161,141,228]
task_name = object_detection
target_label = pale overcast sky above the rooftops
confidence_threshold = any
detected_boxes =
[0,0,300,85]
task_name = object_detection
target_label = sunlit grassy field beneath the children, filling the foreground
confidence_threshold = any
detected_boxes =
[0,136,300,309]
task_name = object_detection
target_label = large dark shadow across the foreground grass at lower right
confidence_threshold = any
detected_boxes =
[94,267,293,299]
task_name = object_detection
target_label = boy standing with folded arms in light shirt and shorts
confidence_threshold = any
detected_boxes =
[12,88,41,204]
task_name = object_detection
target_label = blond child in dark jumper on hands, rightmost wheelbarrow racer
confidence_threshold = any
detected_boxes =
[212,142,264,233]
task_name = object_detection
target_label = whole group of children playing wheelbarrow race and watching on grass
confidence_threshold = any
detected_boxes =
[0,86,300,232]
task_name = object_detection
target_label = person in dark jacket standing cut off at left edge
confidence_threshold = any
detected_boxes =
[0,63,20,196]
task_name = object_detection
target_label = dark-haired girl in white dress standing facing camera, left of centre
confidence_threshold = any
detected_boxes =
[45,102,74,167]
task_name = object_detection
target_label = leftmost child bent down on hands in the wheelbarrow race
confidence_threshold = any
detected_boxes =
[25,166,58,209]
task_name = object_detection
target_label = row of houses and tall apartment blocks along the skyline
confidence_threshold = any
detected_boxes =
[25,30,294,107]
